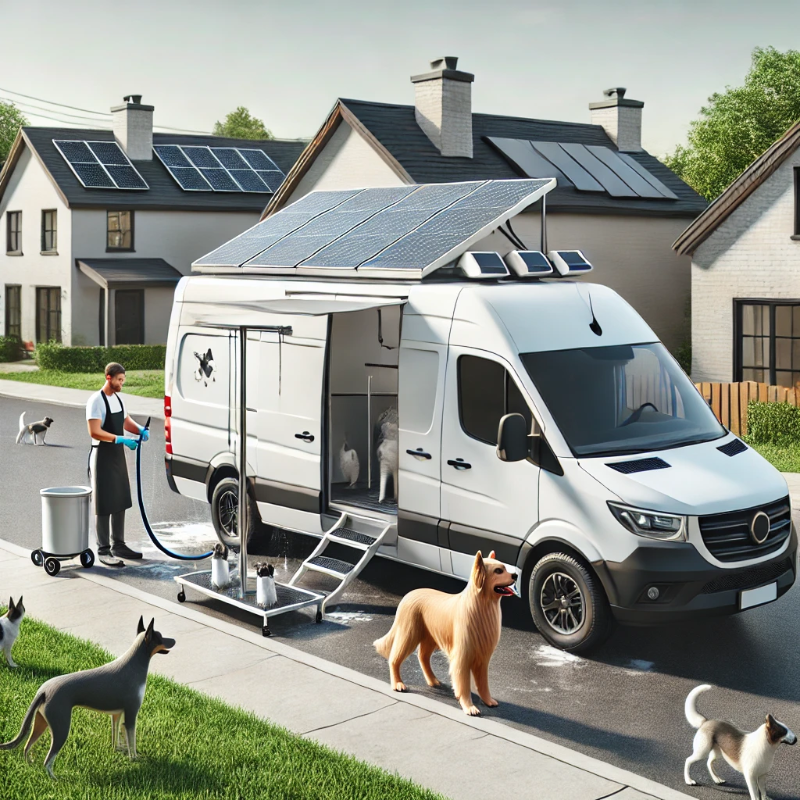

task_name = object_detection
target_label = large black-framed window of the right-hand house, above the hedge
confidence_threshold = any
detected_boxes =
[734,300,800,386]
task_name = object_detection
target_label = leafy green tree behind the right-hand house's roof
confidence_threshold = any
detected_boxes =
[664,47,800,200]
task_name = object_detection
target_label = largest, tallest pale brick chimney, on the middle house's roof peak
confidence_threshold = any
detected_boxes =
[411,56,475,158]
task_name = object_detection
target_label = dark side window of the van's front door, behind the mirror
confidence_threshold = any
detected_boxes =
[458,356,538,445]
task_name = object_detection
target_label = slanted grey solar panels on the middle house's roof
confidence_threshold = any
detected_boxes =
[487,136,678,200]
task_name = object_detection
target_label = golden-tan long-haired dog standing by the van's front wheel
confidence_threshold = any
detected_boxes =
[373,550,518,716]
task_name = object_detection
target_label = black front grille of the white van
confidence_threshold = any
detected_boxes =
[699,496,792,562]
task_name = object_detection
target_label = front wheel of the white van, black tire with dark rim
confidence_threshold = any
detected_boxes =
[528,553,613,653]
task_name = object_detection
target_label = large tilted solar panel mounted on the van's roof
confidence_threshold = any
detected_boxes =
[194,180,555,276]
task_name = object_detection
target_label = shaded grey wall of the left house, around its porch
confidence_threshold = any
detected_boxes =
[72,209,259,344]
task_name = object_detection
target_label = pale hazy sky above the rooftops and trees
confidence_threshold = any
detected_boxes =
[0,0,800,155]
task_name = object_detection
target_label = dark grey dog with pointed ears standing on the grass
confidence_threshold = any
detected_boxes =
[0,617,175,778]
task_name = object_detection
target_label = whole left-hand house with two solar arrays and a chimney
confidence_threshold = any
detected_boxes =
[0,95,304,347]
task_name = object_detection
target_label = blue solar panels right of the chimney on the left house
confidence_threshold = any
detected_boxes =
[153,144,286,194]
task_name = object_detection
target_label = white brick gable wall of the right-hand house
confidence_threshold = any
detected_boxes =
[692,151,800,381]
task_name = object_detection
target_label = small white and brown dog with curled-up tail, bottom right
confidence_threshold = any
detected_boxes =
[683,683,797,800]
